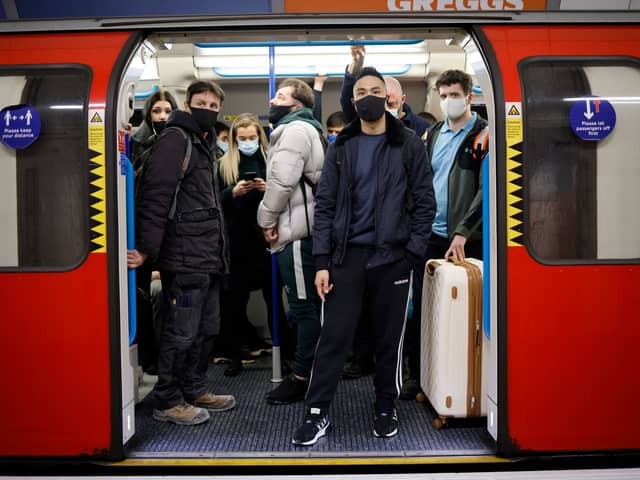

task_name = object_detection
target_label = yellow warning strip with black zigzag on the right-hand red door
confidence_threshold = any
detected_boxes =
[505,102,523,247]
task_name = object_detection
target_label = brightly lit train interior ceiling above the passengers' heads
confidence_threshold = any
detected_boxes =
[126,29,482,126]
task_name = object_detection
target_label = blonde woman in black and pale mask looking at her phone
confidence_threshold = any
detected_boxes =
[220,113,292,376]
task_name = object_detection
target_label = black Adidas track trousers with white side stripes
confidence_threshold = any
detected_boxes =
[305,246,412,409]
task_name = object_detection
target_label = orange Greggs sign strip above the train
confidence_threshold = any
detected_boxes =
[284,0,547,13]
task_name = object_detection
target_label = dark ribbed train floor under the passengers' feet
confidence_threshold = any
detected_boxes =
[126,356,495,459]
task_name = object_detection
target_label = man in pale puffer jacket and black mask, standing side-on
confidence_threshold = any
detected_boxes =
[258,79,324,405]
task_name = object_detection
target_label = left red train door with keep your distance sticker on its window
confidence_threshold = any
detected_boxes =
[0,32,135,457]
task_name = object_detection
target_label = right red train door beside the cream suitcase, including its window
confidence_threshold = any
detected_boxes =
[482,25,640,453]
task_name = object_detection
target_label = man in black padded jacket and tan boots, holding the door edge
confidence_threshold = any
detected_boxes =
[127,81,235,425]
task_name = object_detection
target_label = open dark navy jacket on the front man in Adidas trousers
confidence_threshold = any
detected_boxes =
[313,113,436,270]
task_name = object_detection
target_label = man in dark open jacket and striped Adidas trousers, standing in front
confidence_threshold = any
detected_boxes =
[293,68,435,446]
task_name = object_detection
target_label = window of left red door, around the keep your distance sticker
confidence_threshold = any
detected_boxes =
[0,66,90,270]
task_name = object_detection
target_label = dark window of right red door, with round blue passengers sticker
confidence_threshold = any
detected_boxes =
[519,58,640,263]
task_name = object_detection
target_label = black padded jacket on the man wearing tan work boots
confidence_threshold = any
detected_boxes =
[136,110,228,273]
